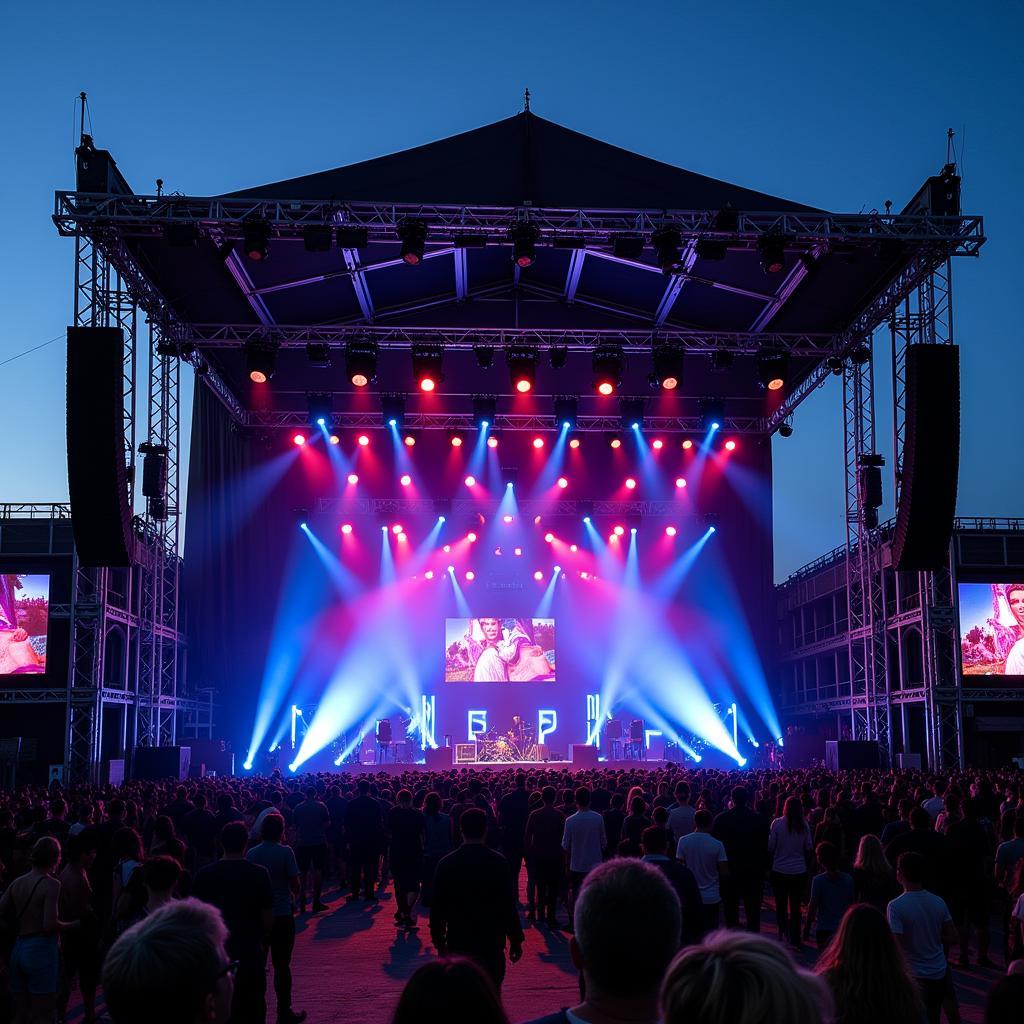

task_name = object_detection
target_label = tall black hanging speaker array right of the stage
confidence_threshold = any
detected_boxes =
[893,345,959,571]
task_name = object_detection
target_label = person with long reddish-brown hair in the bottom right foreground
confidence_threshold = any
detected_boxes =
[815,905,924,1024]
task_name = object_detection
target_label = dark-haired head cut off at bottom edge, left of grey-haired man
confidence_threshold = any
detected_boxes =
[391,956,508,1024]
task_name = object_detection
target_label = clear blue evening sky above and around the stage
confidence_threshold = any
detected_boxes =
[0,0,1024,579]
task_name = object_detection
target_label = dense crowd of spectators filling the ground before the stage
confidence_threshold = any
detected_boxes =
[0,765,1024,1024]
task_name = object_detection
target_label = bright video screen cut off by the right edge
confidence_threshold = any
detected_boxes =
[959,582,1024,685]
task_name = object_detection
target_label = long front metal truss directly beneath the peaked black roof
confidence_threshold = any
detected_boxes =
[53,191,984,255]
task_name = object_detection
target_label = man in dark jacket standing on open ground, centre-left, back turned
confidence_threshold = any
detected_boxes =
[430,807,524,988]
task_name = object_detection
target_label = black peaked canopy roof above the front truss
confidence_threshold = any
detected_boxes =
[222,112,812,213]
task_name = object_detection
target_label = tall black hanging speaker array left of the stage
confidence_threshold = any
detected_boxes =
[68,327,134,566]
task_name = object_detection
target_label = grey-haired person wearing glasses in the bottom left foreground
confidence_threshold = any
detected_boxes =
[103,899,236,1024]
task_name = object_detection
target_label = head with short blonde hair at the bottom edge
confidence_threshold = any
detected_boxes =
[660,931,831,1024]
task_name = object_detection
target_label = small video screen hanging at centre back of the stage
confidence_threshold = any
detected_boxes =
[444,617,555,683]
